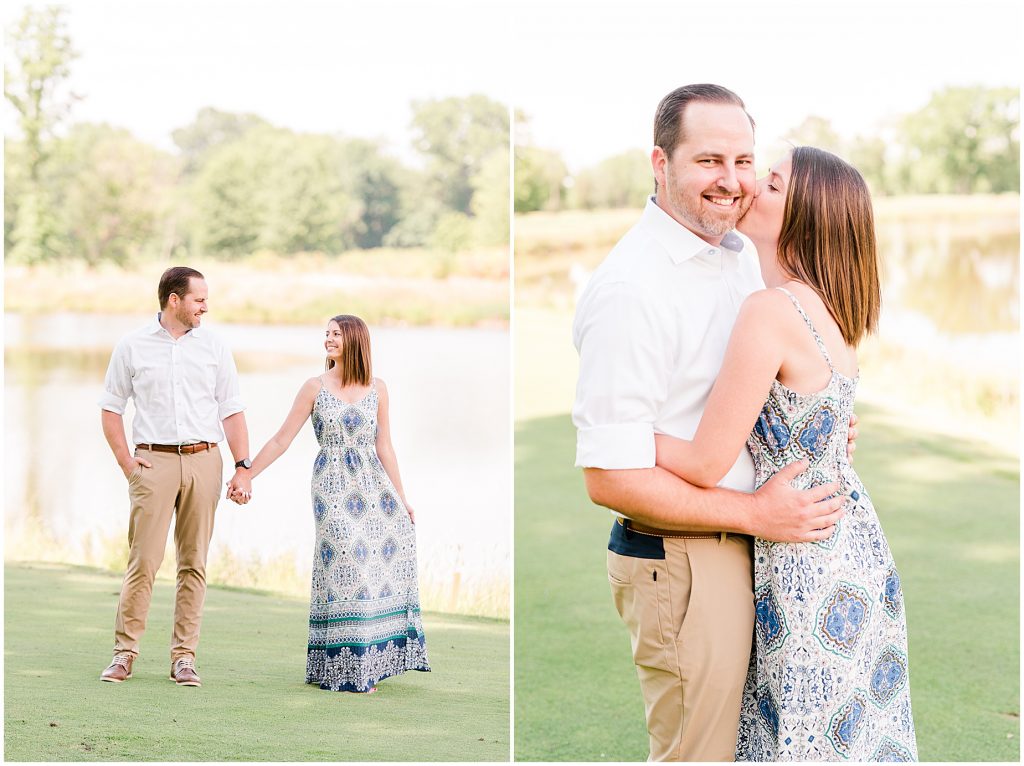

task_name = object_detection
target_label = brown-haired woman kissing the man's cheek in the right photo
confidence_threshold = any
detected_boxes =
[655,147,918,761]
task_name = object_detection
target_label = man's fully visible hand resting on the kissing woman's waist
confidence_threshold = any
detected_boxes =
[751,460,847,543]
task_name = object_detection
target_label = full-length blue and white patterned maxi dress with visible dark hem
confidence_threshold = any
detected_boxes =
[306,379,430,691]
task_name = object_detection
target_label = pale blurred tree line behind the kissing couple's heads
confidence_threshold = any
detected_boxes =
[514,86,1020,213]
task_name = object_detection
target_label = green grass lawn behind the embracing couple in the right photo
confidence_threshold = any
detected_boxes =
[515,406,1020,762]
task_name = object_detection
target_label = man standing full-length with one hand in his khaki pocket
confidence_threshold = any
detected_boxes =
[99,266,252,686]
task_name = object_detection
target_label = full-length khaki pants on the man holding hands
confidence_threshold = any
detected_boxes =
[114,449,223,663]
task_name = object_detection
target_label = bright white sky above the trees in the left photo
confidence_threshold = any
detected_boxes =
[2,0,509,161]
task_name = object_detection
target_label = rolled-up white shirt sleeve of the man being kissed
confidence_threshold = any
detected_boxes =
[572,282,671,469]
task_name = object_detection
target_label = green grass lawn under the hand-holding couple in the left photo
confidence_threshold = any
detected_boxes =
[4,564,509,761]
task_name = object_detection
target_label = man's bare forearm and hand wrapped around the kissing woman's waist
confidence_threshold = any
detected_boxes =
[584,461,846,543]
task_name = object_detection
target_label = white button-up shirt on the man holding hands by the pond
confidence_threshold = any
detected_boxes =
[99,314,245,444]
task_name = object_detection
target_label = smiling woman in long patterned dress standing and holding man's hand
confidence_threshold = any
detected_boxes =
[241,314,430,693]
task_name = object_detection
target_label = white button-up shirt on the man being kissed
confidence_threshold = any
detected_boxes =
[572,198,764,492]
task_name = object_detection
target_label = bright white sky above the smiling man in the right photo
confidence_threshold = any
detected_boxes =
[513,0,1024,170]
